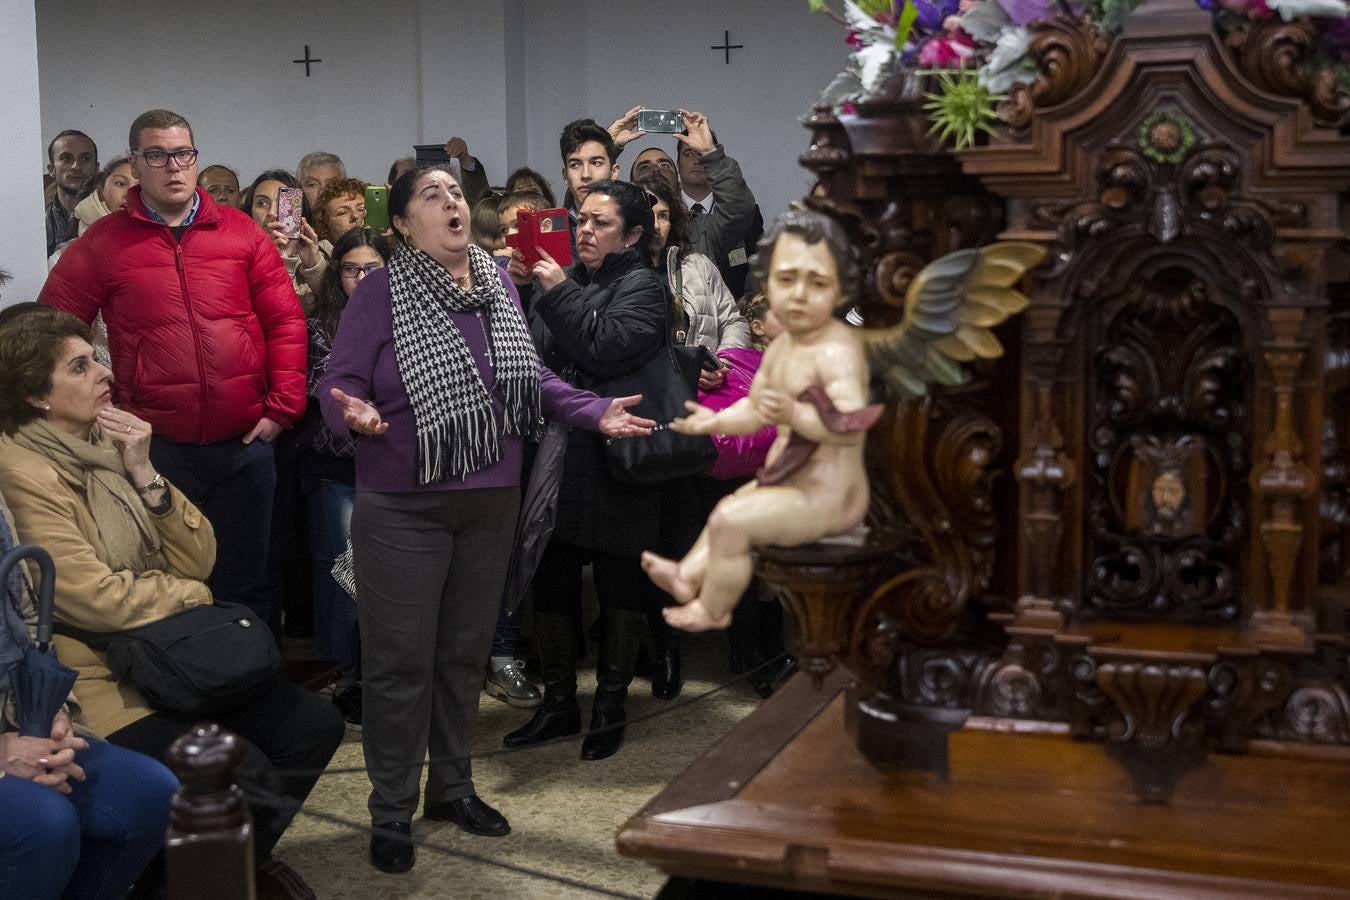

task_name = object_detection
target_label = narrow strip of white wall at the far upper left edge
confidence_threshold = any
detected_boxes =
[0,0,47,305]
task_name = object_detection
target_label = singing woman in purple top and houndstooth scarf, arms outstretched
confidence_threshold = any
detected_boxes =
[319,166,653,872]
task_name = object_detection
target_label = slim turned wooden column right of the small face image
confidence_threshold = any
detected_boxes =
[1251,348,1316,648]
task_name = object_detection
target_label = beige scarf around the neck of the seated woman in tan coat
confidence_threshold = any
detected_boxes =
[12,418,166,573]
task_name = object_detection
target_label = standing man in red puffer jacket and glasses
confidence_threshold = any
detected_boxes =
[39,109,305,625]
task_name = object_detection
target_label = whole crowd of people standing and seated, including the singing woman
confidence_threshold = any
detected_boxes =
[0,101,790,897]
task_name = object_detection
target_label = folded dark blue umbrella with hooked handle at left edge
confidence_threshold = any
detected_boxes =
[0,544,77,738]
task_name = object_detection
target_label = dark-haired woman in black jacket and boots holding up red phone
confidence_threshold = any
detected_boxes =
[505,181,680,760]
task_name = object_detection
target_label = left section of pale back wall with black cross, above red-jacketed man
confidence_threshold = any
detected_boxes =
[36,0,421,184]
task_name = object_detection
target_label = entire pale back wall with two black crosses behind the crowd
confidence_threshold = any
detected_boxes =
[36,0,848,229]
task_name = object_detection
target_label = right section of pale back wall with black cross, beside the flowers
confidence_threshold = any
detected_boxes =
[528,0,848,219]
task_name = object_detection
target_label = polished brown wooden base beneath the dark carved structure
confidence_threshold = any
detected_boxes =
[618,672,1350,899]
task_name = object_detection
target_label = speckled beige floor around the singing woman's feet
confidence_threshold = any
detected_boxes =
[277,633,759,900]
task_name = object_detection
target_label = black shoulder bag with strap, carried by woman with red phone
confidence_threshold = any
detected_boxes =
[605,248,717,484]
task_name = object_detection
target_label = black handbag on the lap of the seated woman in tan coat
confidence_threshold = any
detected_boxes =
[72,603,281,715]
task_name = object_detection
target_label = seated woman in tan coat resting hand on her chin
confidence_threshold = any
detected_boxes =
[0,309,343,881]
